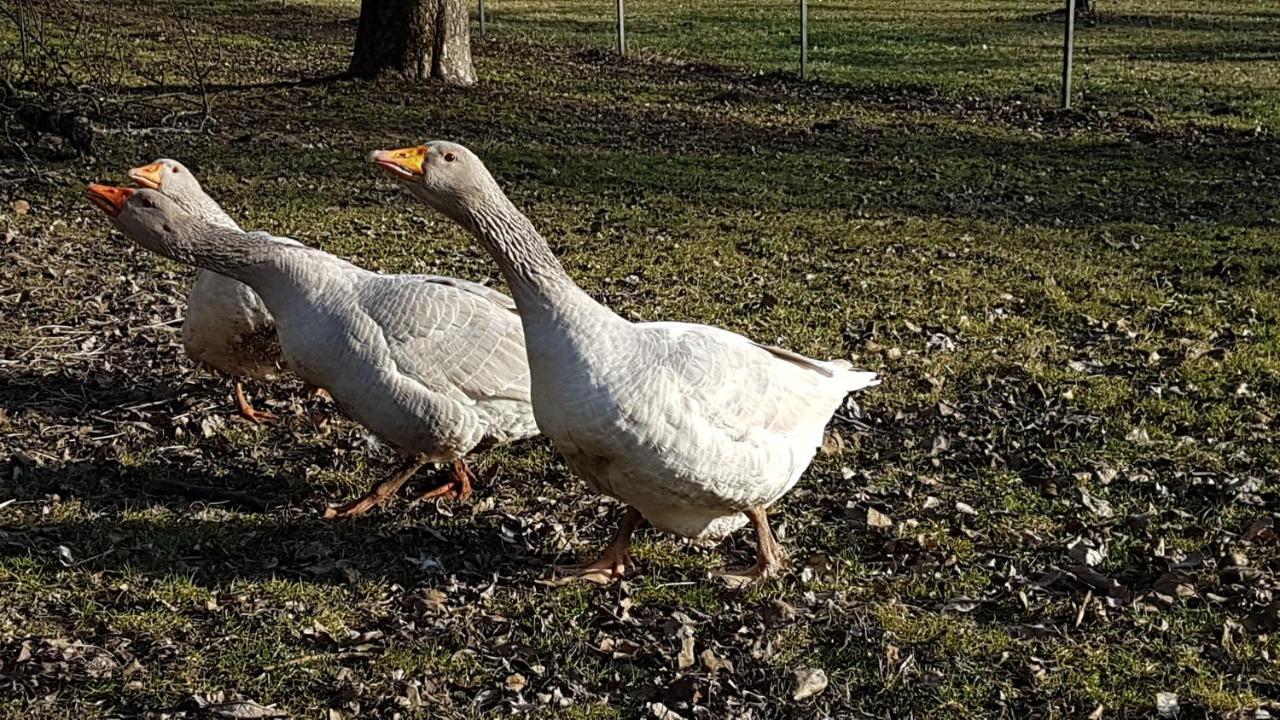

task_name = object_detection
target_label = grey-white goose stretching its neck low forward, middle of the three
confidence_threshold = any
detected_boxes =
[88,184,538,518]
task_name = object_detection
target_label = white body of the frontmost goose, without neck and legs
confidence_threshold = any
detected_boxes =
[526,313,876,541]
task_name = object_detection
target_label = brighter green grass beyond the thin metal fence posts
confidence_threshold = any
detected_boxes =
[488,0,1280,127]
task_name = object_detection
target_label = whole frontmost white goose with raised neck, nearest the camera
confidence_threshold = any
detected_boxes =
[371,142,878,583]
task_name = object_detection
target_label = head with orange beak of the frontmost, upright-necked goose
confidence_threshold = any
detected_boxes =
[369,140,502,222]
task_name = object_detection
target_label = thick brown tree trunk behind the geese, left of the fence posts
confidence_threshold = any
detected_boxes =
[348,0,476,85]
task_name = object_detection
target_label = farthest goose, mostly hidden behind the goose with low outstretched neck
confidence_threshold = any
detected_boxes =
[129,159,302,423]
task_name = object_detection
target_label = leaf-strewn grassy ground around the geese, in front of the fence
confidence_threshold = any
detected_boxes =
[0,0,1280,719]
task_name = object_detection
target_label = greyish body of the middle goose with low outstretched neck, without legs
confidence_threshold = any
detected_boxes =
[242,239,538,453]
